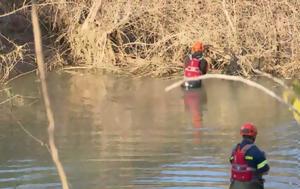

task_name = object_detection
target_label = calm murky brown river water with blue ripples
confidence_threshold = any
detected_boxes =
[0,73,300,189]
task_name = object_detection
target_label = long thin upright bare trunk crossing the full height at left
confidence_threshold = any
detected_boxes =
[31,0,69,189]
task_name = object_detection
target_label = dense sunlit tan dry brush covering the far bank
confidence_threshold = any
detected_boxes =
[0,0,300,77]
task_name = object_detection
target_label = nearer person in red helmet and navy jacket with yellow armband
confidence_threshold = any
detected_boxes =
[230,123,270,189]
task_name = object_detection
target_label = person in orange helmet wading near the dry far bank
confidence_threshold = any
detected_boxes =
[182,41,208,89]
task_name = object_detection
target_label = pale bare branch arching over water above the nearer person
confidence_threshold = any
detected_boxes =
[165,74,300,115]
